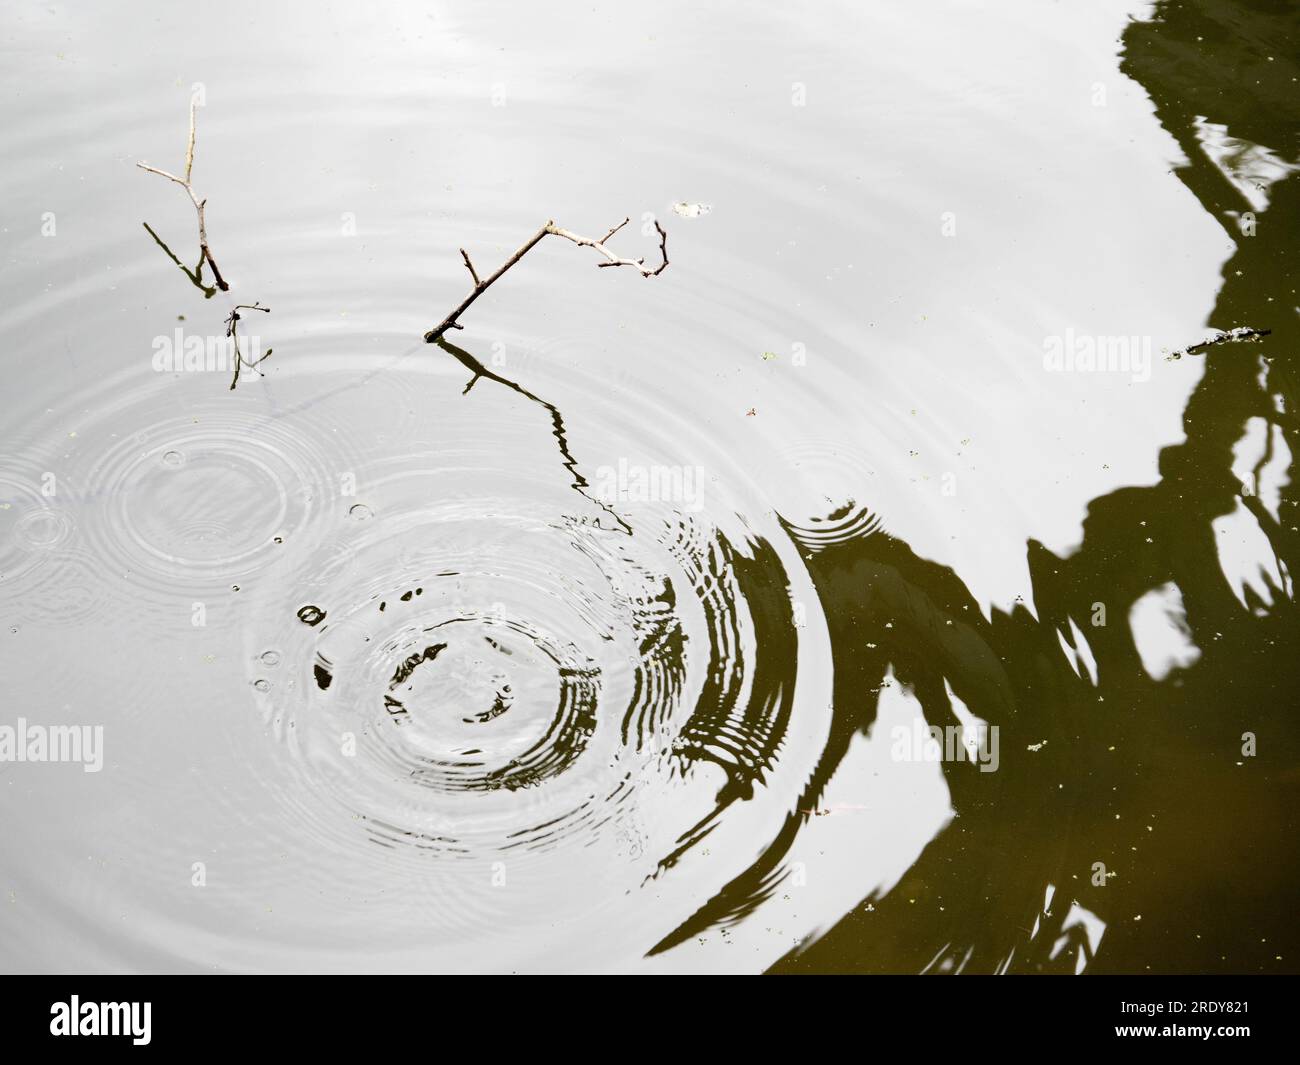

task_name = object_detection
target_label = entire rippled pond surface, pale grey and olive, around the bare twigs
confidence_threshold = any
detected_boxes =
[0,0,1300,973]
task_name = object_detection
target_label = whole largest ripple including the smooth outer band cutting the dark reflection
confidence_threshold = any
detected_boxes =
[237,366,828,949]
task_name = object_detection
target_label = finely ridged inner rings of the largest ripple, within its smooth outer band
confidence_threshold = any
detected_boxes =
[251,496,793,850]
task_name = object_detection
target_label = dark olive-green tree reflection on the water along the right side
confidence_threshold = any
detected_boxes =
[776,4,1300,973]
